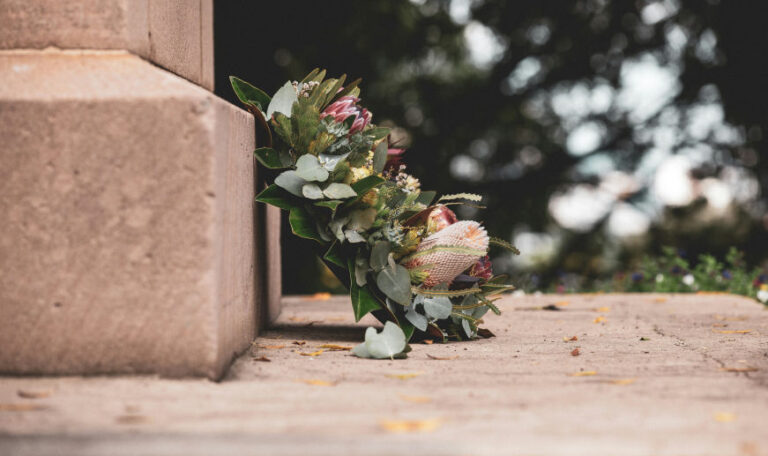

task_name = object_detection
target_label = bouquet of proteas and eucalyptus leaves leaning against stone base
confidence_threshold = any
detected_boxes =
[230,69,517,357]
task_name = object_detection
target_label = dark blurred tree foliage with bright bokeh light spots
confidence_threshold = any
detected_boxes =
[215,0,768,293]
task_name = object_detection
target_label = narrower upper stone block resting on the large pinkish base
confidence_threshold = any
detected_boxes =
[0,0,214,90]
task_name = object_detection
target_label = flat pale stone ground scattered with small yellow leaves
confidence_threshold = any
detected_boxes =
[0,295,768,456]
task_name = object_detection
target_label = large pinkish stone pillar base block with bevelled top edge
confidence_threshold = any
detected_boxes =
[0,50,258,378]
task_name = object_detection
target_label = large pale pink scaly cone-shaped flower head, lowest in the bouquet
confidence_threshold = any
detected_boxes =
[403,220,488,288]
